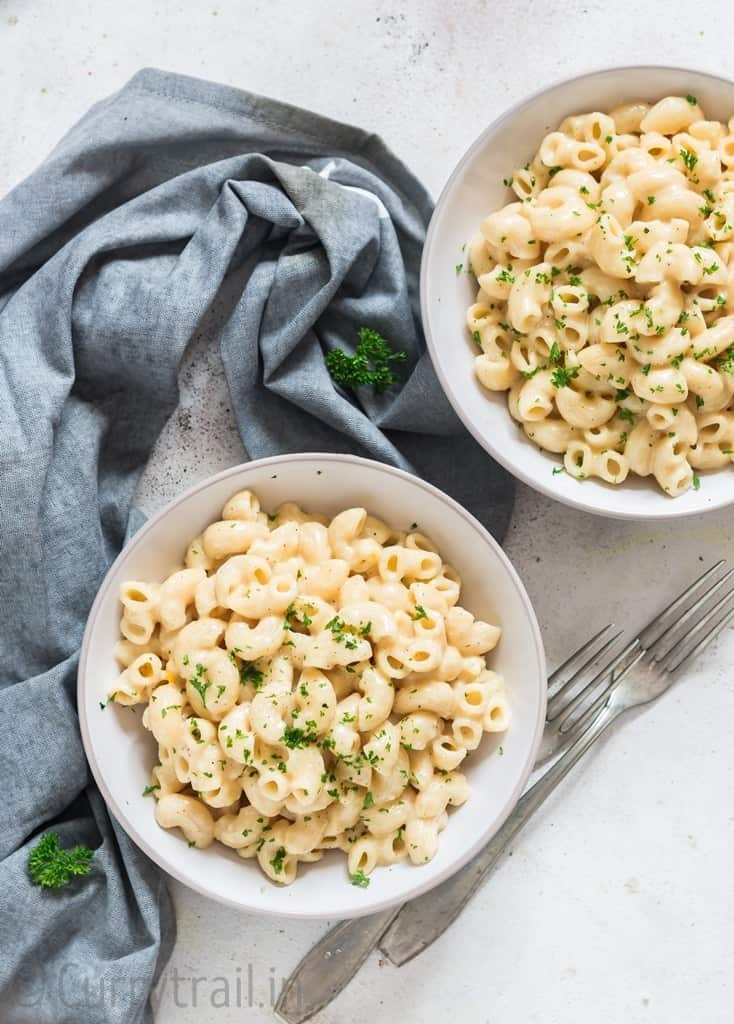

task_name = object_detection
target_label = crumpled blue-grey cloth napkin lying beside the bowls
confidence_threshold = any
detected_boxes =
[0,70,512,1024]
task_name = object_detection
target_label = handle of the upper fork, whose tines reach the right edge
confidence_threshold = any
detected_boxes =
[380,707,619,967]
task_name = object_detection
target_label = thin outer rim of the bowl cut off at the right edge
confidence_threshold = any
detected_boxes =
[420,63,734,522]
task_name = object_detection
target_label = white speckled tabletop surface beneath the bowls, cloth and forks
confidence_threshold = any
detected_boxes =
[0,0,734,1024]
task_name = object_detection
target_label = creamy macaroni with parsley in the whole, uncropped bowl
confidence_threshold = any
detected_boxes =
[110,490,509,886]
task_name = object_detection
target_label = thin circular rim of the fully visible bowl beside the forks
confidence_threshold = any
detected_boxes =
[76,452,547,920]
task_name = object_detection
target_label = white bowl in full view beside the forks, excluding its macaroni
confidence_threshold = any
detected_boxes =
[78,455,546,918]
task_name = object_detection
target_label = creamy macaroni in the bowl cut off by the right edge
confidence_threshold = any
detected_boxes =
[467,95,734,497]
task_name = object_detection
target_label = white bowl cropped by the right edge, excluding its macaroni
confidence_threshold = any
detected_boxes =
[421,67,734,519]
